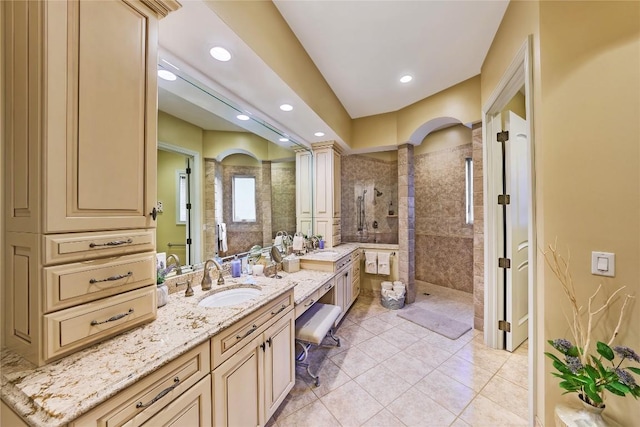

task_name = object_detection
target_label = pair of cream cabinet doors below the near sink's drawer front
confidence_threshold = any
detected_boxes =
[212,309,295,427]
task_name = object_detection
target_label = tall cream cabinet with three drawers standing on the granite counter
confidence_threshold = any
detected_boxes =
[2,0,180,365]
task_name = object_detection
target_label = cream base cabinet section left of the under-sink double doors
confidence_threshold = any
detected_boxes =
[69,342,212,427]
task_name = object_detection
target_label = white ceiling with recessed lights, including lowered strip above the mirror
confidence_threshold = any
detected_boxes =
[159,0,508,150]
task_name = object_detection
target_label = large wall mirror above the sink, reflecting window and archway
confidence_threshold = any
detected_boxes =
[156,55,312,265]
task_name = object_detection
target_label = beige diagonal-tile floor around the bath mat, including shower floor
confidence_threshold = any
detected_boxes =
[268,285,528,427]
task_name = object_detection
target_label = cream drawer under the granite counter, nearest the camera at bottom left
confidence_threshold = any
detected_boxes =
[69,342,211,427]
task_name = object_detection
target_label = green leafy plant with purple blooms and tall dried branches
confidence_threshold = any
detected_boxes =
[544,241,640,407]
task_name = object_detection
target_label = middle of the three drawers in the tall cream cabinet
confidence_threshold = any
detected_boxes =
[44,252,156,313]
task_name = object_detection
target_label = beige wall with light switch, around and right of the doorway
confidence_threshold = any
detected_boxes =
[481,1,640,425]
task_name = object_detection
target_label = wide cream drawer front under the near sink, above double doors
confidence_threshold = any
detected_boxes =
[211,291,294,369]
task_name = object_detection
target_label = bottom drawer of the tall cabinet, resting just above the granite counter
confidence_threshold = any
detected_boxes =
[44,285,157,359]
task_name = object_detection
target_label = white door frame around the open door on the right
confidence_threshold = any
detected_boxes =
[482,35,538,425]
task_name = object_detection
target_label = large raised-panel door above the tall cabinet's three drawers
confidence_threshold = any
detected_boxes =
[45,1,157,232]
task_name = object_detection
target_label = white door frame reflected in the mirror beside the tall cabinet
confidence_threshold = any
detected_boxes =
[158,141,204,265]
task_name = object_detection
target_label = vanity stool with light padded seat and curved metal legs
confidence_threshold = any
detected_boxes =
[296,302,342,387]
